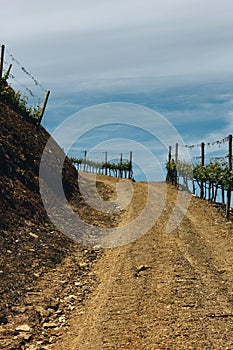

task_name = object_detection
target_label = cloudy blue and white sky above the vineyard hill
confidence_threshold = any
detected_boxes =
[0,0,233,180]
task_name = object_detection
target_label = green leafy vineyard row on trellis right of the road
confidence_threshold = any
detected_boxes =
[166,135,233,217]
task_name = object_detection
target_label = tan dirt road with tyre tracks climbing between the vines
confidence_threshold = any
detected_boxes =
[49,183,233,350]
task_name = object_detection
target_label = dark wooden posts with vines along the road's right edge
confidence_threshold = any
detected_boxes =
[166,135,233,218]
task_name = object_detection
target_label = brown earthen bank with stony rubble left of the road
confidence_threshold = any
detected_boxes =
[0,101,120,350]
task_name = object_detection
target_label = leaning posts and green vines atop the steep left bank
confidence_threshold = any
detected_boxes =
[0,45,50,126]
